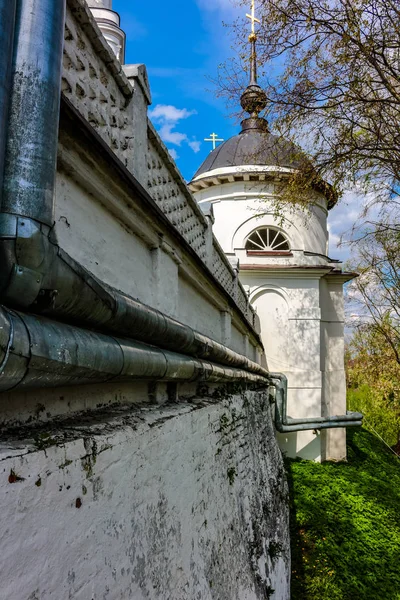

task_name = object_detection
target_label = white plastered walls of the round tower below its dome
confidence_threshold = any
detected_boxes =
[192,167,349,460]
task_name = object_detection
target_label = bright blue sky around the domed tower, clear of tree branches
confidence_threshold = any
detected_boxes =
[113,0,361,260]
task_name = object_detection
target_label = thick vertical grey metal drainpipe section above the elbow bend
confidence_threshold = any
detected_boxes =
[1,0,65,226]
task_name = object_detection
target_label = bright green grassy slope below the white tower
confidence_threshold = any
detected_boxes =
[286,429,400,600]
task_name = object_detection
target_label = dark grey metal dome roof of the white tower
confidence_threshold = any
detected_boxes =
[193,118,310,179]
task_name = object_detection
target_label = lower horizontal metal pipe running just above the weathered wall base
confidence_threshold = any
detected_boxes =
[0,307,267,392]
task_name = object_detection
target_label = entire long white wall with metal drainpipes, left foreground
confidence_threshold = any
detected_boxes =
[0,0,290,600]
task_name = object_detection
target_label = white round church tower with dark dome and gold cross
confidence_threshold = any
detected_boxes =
[189,0,359,460]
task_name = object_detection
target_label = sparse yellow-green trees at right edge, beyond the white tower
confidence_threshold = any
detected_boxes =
[346,227,400,453]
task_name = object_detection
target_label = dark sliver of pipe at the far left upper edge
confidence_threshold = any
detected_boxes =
[0,0,16,198]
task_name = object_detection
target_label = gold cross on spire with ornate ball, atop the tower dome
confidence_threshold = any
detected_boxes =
[240,0,267,129]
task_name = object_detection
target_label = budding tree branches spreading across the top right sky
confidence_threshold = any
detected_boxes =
[222,0,400,206]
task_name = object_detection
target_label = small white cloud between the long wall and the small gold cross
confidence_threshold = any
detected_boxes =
[149,104,200,158]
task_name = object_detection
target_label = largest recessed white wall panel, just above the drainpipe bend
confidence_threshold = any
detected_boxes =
[55,172,158,308]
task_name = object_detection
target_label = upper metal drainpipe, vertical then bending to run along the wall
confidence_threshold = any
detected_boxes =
[0,0,268,378]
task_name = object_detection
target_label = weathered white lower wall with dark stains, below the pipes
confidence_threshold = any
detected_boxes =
[0,392,290,600]
